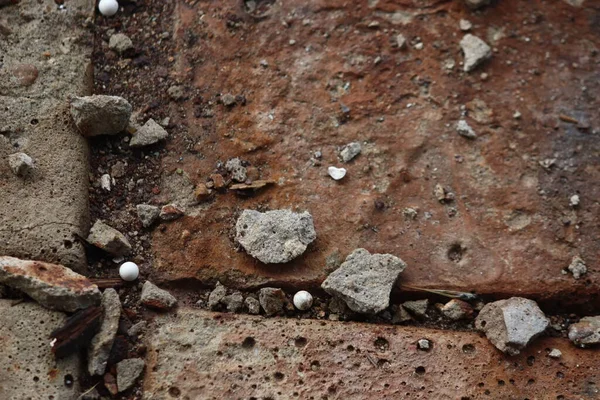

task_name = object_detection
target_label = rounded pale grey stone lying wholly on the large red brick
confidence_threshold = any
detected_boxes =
[235,210,317,264]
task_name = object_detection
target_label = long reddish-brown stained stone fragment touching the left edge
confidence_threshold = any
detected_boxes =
[0,257,101,312]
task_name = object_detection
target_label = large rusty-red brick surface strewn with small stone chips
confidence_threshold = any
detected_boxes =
[152,0,600,303]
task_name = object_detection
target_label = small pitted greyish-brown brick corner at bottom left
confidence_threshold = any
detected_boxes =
[0,300,81,400]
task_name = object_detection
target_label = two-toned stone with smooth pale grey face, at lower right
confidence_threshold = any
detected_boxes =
[475,297,550,355]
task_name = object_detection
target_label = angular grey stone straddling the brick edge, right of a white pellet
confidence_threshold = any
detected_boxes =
[321,249,406,314]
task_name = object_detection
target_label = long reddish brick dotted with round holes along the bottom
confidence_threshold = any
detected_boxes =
[144,309,600,400]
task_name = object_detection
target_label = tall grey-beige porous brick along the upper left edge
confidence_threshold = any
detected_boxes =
[0,0,94,271]
